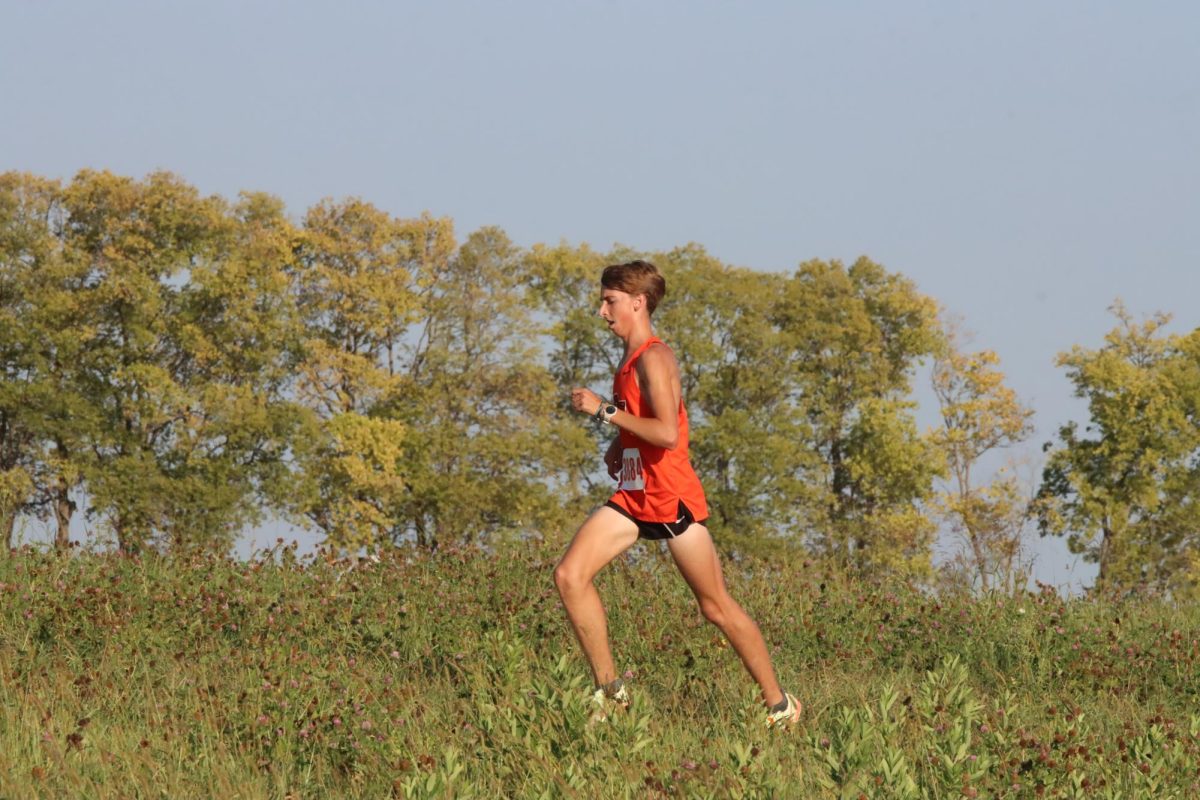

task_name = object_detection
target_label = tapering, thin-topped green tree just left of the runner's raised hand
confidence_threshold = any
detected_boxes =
[388,228,583,547]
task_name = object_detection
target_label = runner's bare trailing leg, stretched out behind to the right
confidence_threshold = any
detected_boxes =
[667,523,784,705]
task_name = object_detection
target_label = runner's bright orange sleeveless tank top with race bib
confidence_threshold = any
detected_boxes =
[612,336,708,522]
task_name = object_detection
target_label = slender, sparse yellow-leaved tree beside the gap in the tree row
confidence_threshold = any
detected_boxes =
[932,324,1033,591]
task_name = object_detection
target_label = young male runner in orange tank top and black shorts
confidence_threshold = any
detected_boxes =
[554,260,802,727]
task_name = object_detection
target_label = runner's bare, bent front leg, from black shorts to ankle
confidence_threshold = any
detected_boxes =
[554,506,637,686]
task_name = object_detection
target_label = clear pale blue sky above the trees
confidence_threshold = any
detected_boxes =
[0,0,1200,583]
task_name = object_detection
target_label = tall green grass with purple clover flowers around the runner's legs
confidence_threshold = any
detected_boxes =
[0,543,1200,799]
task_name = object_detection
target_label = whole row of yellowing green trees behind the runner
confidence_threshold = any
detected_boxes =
[0,170,1200,594]
